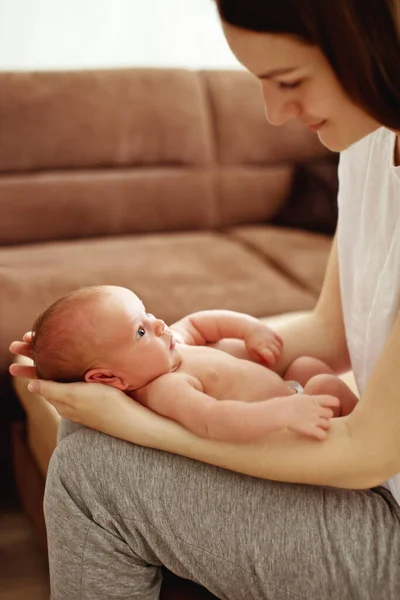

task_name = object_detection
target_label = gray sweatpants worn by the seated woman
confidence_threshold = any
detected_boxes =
[45,424,400,600]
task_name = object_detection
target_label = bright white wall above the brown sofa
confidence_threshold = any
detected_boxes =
[0,0,240,71]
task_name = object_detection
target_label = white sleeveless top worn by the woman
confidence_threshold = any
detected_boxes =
[338,128,400,504]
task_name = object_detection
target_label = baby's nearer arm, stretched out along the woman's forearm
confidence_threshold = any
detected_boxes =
[134,373,338,443]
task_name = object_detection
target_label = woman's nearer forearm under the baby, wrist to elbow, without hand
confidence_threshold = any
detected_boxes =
[93,401,381,489]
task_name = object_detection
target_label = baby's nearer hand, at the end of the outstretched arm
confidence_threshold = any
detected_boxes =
[285,394,340,440]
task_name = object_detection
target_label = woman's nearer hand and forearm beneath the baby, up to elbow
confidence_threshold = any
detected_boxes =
[24,381,362,488]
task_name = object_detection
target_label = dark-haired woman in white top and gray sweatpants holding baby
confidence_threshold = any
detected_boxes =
[8,0,400,600]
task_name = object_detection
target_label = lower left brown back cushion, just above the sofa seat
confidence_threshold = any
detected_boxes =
[0,167,217,245]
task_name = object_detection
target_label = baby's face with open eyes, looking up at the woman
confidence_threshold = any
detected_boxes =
[100,286,180,390]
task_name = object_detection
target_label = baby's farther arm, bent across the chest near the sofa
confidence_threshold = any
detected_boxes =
[170,310,283,364]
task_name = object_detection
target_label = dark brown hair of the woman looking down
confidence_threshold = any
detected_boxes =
[216,0,400,130]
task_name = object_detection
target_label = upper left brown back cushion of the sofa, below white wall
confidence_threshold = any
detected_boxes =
[0,69,212,173]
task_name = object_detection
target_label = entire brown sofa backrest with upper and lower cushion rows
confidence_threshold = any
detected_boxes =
[0,69,336,245]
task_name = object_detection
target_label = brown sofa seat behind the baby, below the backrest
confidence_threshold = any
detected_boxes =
[0,226,331,378]
